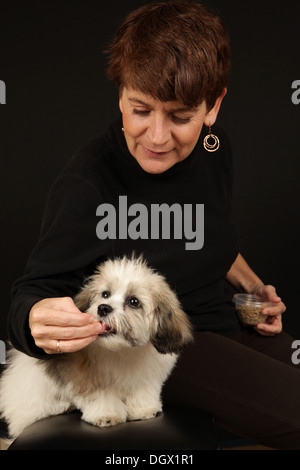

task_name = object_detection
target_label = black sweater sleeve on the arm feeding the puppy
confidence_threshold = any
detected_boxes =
[8,176,101,358]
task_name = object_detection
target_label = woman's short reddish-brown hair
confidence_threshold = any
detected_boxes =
[107,0,230,110]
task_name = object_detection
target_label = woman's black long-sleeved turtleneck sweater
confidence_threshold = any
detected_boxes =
[8,119,239,358]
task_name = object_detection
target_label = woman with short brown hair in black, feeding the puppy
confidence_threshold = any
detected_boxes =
[5,1,300,449]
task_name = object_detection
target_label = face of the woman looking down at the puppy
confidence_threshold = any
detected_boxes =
[120,88,226,173]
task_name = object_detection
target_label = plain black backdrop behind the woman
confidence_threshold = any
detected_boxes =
[0,0,300,356]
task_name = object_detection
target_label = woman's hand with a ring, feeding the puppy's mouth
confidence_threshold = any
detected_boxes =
[29,297,103,354]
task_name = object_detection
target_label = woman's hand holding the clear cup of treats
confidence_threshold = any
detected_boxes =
[251,284,286,336]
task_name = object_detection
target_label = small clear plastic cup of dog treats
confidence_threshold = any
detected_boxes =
[232,294,274,325]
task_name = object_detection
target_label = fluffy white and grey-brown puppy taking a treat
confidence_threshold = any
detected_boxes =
[0,258,192,437]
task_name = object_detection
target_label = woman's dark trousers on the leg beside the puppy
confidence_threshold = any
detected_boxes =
[163,328,300,450]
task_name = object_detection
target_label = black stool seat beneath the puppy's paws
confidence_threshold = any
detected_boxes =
[8,407,219,450]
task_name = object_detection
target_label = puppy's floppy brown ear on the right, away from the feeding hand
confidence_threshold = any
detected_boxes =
[150,283,193,354]
